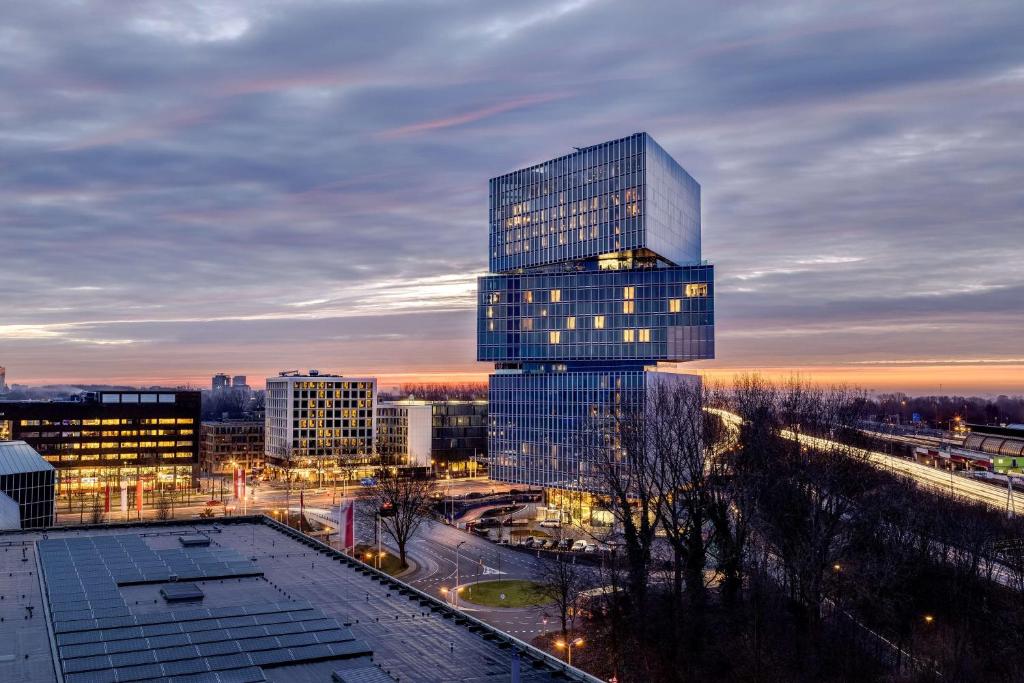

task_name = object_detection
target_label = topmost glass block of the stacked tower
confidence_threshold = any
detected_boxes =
[489,133,700,272]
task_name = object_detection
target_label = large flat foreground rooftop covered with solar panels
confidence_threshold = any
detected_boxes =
[0,517,596,683]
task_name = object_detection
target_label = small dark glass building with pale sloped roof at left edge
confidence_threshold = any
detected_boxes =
[0,441,56,529]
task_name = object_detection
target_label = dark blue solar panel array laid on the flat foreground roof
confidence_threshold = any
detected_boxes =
[37,535,372,683]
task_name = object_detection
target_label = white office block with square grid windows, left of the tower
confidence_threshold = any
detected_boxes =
[265,370,377,476]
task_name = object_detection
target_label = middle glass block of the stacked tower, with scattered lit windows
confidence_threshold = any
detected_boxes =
[476,265,715,362]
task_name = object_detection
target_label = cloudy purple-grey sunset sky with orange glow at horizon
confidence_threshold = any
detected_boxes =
[0,0,1024,393]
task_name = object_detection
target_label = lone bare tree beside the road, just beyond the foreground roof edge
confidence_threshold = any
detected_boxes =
[360,467,436,568]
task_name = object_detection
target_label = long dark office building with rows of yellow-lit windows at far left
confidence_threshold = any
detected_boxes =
[0,389,200,496]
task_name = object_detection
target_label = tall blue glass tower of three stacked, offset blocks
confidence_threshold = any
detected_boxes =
[477,133,715,489]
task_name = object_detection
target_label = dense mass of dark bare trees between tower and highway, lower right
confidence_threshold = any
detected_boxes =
[561,376,1024,681]
